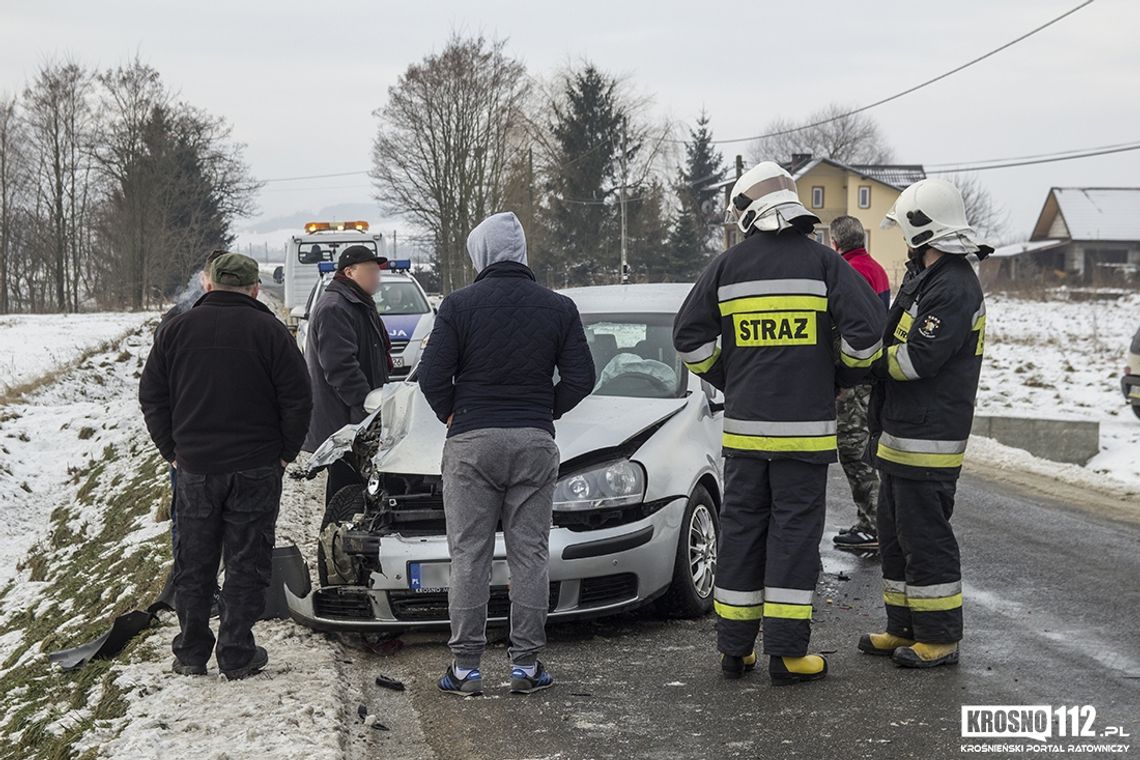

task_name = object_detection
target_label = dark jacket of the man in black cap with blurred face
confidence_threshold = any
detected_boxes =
[304,278,391,451]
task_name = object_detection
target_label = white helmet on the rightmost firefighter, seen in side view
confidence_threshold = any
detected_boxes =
[882,179,993,258]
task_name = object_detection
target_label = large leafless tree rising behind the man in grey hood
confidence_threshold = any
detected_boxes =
[371,35,529,293]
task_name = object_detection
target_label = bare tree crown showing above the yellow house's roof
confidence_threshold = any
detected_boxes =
[751,103,891,164]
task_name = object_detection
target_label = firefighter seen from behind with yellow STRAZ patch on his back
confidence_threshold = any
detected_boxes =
[673,162,884,685]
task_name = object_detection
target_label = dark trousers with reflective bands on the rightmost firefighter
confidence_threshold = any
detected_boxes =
[878,472,962,644]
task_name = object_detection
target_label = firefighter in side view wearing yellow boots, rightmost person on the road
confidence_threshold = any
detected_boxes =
[858,179,993,668]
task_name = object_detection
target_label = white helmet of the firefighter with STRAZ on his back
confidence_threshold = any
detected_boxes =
[724,161,820,232]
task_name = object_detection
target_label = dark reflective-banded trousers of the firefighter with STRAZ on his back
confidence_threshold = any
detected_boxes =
[714,457,828,657]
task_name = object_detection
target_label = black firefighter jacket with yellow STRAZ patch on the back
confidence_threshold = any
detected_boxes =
[673,229,884,463]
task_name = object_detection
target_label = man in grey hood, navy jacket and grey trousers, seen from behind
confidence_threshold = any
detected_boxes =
[416,212,594,695]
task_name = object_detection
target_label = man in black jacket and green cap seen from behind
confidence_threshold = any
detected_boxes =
[139,253,312,678]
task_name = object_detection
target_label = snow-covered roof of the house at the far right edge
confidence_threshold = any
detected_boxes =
[1029,187,1140,240]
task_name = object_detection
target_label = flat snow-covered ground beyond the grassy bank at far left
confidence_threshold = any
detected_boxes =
[0,311,156,392]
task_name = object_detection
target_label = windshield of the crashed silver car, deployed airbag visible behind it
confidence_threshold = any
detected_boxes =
[581,314,685,399]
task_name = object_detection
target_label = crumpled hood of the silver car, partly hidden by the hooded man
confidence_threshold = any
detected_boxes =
[373,383,686,475]
